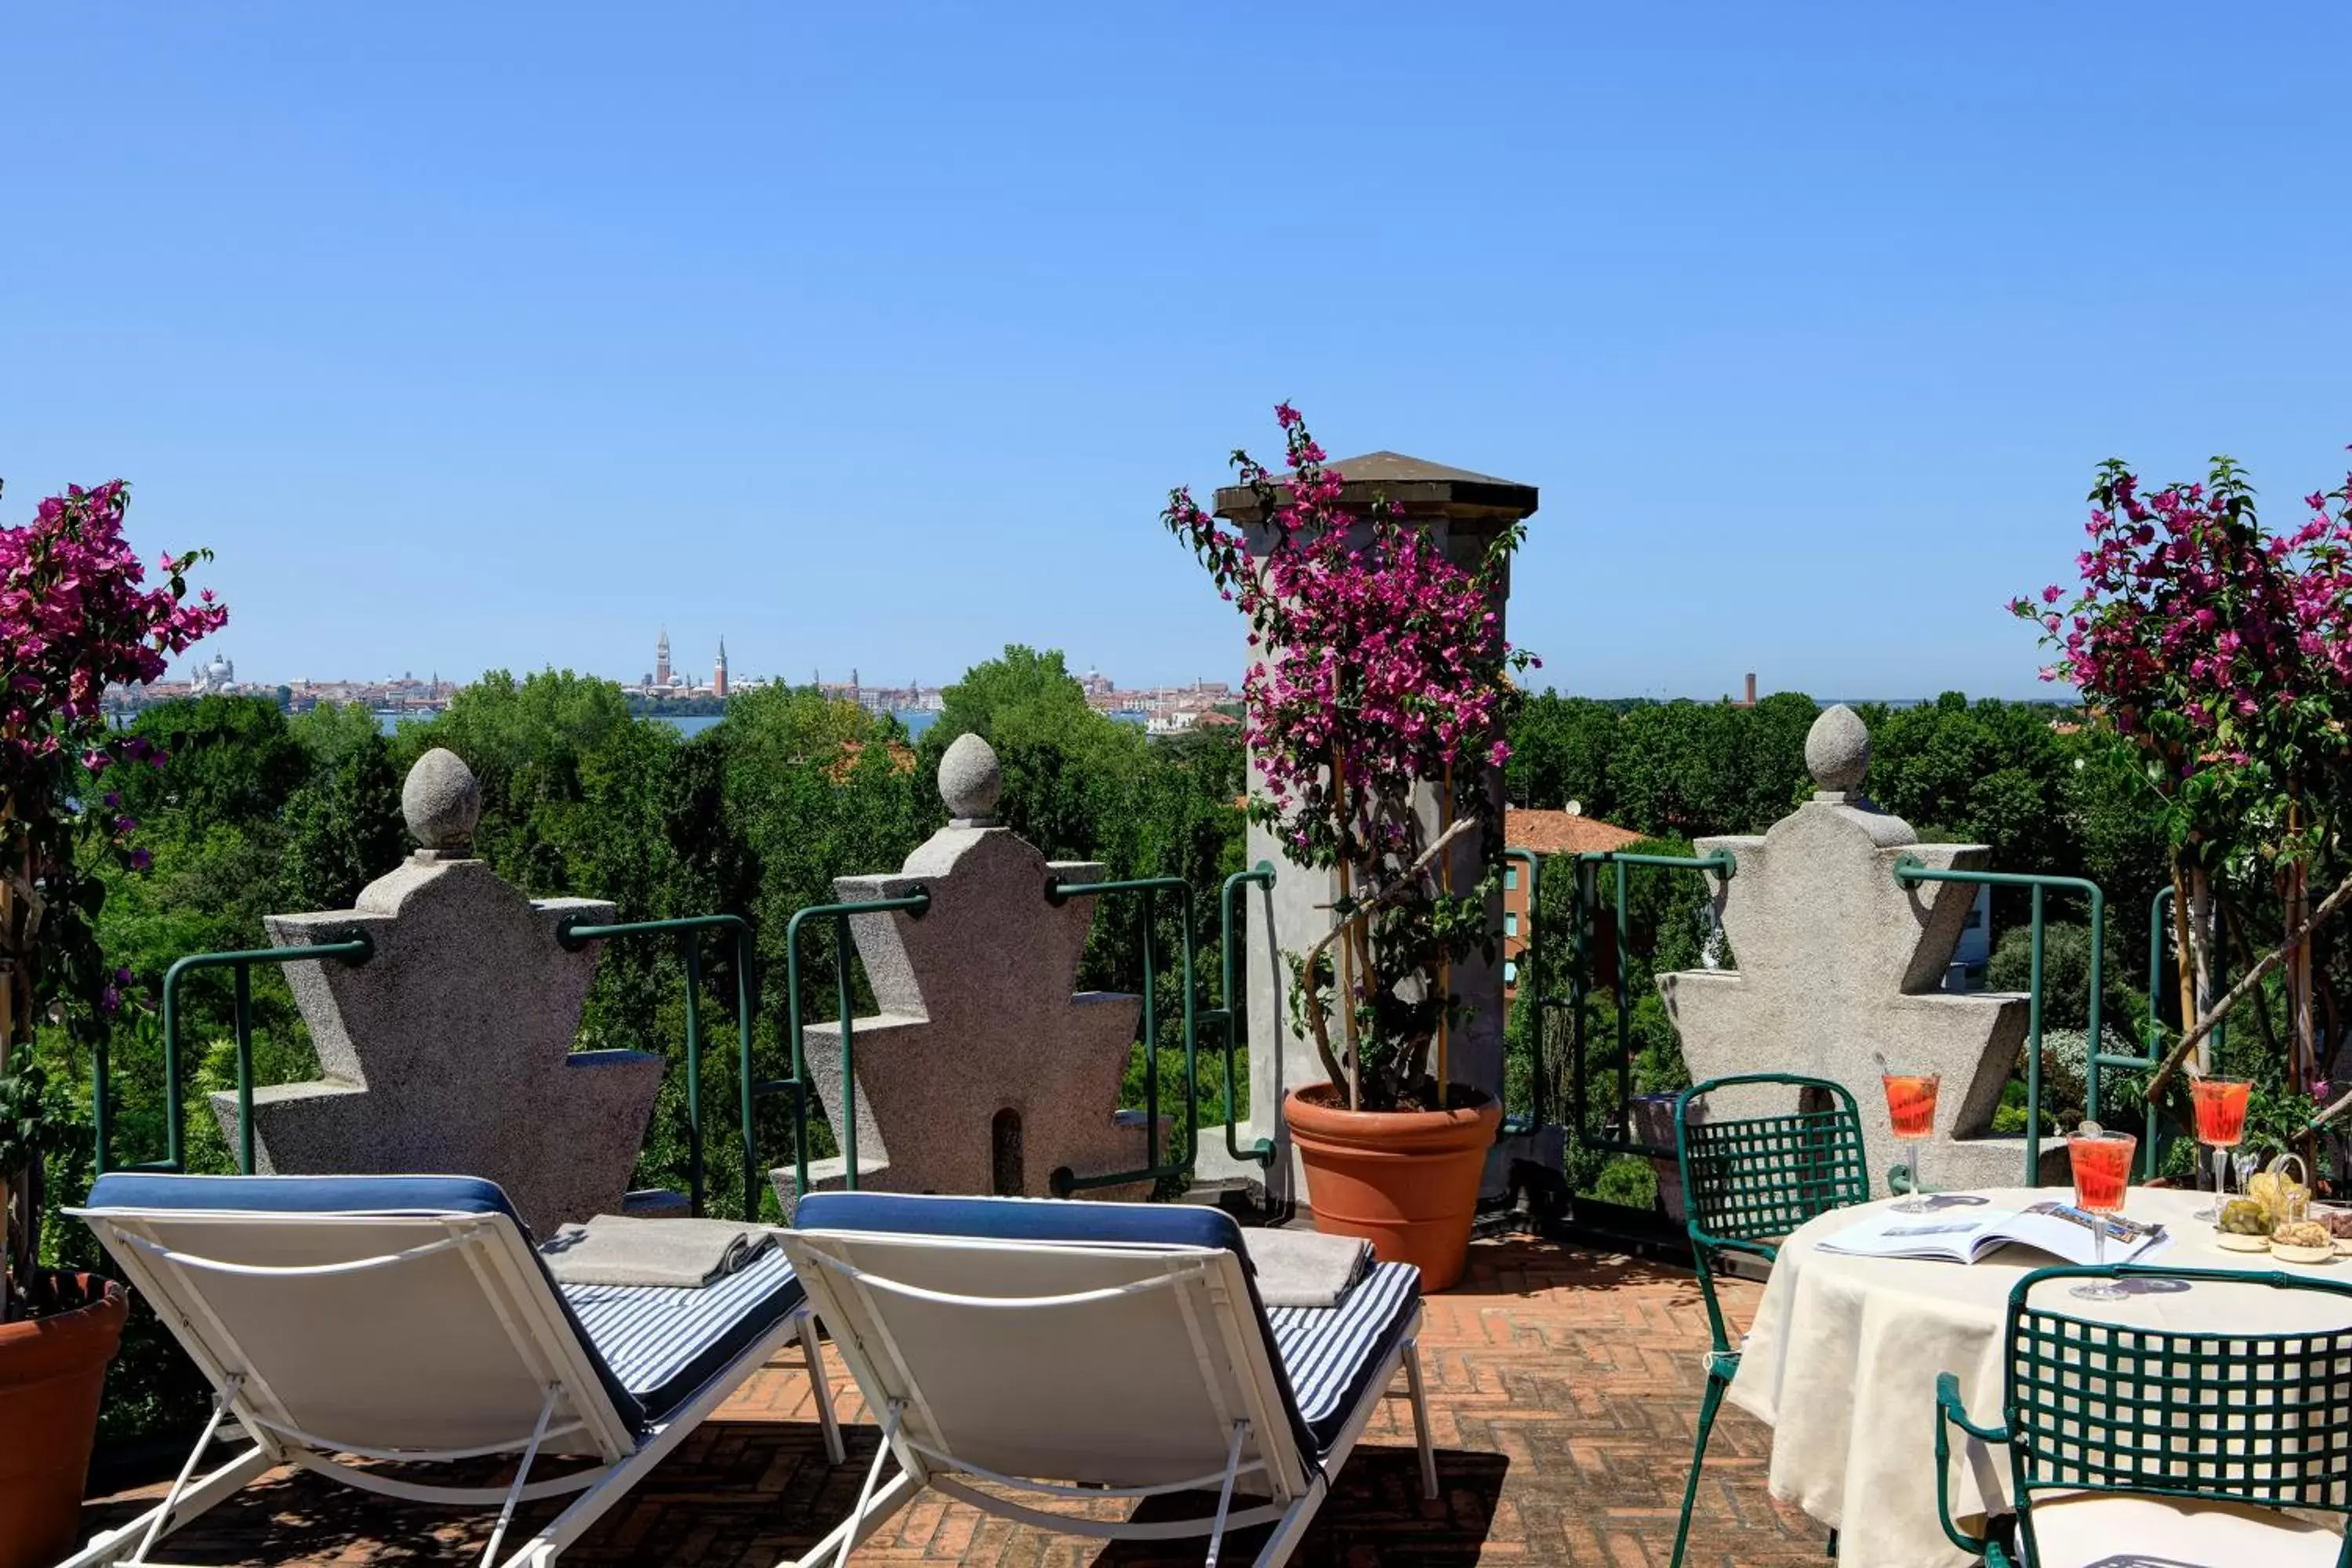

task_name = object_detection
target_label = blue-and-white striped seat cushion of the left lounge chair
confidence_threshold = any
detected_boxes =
[562,1248,804,1422]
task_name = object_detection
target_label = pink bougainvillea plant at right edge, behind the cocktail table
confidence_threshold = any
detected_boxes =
[2011,446,2352,1091]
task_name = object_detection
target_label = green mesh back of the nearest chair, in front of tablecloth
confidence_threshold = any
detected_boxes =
[2004,1267,2352,1561]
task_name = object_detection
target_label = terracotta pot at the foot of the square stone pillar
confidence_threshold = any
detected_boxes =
[1282,1083,1503,1290]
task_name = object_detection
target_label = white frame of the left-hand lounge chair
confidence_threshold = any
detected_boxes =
[59,1208,844,1568]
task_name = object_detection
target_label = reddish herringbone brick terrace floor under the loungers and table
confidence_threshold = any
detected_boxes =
[87,1239,1825,1568]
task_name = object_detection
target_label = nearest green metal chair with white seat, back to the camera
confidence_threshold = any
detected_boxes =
[1936,1265,2352,1568]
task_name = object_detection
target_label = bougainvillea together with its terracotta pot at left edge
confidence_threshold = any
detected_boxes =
[0,482,228,1568]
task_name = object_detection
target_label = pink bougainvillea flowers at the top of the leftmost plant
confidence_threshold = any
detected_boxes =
[0,480,228,837]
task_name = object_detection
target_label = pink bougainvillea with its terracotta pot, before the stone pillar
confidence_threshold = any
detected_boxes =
[1162,405,1534,1290]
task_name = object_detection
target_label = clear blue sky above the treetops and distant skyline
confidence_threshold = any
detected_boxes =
[0,0,2352,696]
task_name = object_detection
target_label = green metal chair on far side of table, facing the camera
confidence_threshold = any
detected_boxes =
[1672,1072,1870,1568]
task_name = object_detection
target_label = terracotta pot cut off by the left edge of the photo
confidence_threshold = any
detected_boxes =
[0,1274,129,1568]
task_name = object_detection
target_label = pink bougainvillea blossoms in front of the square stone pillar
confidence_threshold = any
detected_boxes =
[1162,405,1534,853]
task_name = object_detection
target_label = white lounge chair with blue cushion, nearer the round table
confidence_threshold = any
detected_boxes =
[783,1192,1437,1566]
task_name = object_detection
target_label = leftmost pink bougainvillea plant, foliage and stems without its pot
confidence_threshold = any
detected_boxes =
[0,480,228,1316]
